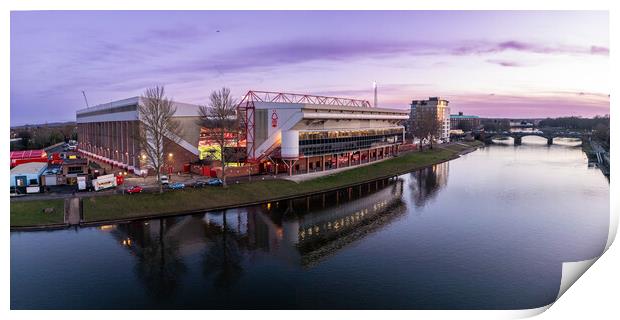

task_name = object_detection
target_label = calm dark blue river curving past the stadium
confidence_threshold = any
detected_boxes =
[10,137,609,309]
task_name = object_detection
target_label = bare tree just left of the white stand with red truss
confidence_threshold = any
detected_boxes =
[199,87,238,186]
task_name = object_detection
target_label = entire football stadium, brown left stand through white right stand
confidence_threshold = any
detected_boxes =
[76,91,409,176]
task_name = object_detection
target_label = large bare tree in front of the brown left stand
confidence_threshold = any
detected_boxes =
[136,86,181,193]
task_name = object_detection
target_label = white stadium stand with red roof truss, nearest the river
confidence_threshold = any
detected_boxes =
[238,91,409,175]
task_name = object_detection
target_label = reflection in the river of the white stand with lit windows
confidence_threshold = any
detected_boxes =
[248,179,406,267]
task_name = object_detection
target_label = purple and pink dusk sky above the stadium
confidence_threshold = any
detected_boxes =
[10,11,610,126]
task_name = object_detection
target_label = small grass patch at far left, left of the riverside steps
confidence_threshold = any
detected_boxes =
[10,199,64,227]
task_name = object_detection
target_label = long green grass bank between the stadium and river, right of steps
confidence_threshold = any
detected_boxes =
[83,143,477,222]
